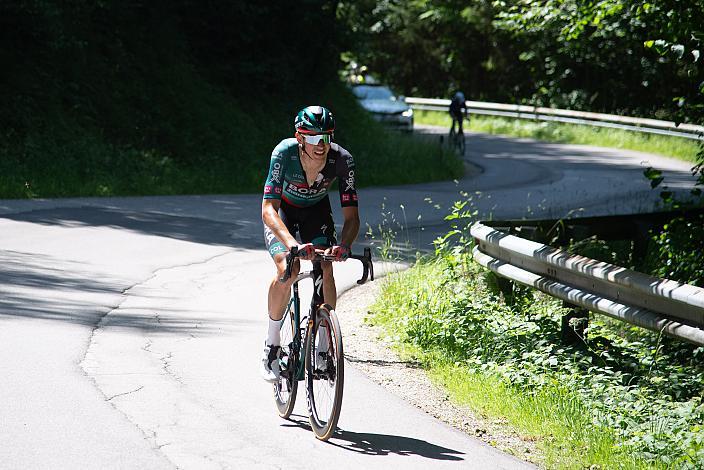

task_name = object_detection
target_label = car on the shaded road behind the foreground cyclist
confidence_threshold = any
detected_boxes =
[352,83,413,131]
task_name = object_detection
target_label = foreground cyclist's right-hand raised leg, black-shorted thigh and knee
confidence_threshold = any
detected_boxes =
[299,196,337,308]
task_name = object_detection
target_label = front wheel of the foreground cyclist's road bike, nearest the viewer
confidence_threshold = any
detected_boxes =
[305,305,345,441]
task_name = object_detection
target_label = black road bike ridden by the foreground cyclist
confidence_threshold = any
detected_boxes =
[274,247,374,441]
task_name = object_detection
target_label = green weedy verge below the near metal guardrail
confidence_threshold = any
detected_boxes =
[369,250,704,468]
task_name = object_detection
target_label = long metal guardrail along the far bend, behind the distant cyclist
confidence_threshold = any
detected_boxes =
[406,97,704,139]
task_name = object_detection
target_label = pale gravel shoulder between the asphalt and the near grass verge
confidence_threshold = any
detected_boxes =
[336,279,542,465]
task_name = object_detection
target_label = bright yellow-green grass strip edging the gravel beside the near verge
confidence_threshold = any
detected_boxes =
[371,292,649,468]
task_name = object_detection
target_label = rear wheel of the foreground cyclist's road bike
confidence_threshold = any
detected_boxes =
[274,310,300,419]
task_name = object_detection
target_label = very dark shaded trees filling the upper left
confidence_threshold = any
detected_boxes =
[0,0,343,161]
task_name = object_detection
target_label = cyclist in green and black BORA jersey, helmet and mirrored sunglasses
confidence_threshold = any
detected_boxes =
[261,106,359,382]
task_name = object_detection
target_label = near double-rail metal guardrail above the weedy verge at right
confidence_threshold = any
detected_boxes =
[470,223,704,346]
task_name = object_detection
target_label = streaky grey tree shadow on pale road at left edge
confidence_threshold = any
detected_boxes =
[0,250,255,334]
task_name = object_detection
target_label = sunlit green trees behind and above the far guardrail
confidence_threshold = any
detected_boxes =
[338,0,704,121]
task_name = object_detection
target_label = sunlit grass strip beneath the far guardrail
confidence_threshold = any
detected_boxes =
[415,110,698,162]
